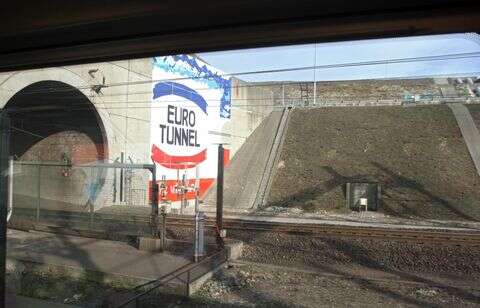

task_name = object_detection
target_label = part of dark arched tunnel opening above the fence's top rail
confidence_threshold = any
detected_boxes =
[6,81,107,164]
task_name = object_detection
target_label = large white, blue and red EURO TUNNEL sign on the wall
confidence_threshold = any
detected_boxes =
[150,55,231,201]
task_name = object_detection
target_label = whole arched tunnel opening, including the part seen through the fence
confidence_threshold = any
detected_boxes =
[6,81,108,213]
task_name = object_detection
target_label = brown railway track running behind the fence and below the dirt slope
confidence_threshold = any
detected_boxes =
[9,211,480,247]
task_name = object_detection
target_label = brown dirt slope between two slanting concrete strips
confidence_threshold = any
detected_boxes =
[269,105,480,221]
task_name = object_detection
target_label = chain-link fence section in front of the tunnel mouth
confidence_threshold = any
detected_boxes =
[12,161,151,237]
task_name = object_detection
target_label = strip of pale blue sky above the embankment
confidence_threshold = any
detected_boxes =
[198,33,480,81]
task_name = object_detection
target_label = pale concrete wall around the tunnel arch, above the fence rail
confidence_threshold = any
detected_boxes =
[0,59,152,162]
